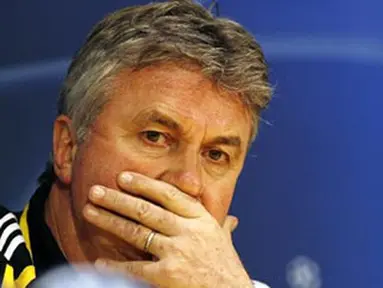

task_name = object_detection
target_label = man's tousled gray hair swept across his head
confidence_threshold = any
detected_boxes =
[39,0,272,184]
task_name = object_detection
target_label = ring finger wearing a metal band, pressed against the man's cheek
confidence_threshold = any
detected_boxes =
[84,204,170,258]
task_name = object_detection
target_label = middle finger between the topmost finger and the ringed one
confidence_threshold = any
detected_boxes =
[89,186,185,236]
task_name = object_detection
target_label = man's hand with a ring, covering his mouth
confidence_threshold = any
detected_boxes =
[84,173,252,288]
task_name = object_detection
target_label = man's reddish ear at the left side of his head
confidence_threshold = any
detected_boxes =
[53,115,77,185]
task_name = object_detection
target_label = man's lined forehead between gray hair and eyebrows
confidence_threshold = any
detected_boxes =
[111,63,251,140]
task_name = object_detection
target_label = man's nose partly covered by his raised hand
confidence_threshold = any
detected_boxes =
[159,153,203,199]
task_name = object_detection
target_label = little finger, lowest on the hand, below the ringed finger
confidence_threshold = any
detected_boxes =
[95,259,161,285]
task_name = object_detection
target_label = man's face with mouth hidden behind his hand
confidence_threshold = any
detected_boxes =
[71,64,255,258]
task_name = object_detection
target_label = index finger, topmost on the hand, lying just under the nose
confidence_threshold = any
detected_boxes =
[118,172,207,218]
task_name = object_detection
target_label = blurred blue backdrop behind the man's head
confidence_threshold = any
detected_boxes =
[0,0,383,288]
